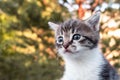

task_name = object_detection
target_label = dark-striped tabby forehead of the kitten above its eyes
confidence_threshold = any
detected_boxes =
[60,19,91,33]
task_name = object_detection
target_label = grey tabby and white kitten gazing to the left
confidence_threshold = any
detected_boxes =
[48,11,120,80]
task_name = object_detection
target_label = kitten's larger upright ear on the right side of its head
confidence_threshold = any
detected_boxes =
[85,11,100,31]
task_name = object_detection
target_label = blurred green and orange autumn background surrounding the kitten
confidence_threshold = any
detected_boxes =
[0,0,120,80]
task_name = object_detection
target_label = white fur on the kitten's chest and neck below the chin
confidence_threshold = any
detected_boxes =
[62,48,104,80]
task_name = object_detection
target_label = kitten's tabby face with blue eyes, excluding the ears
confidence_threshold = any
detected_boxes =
[55,20,99,54]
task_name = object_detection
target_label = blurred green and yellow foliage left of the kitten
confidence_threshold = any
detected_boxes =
[0,0,68,80]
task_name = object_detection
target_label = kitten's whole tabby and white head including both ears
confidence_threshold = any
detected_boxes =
[48,12,100,55]
